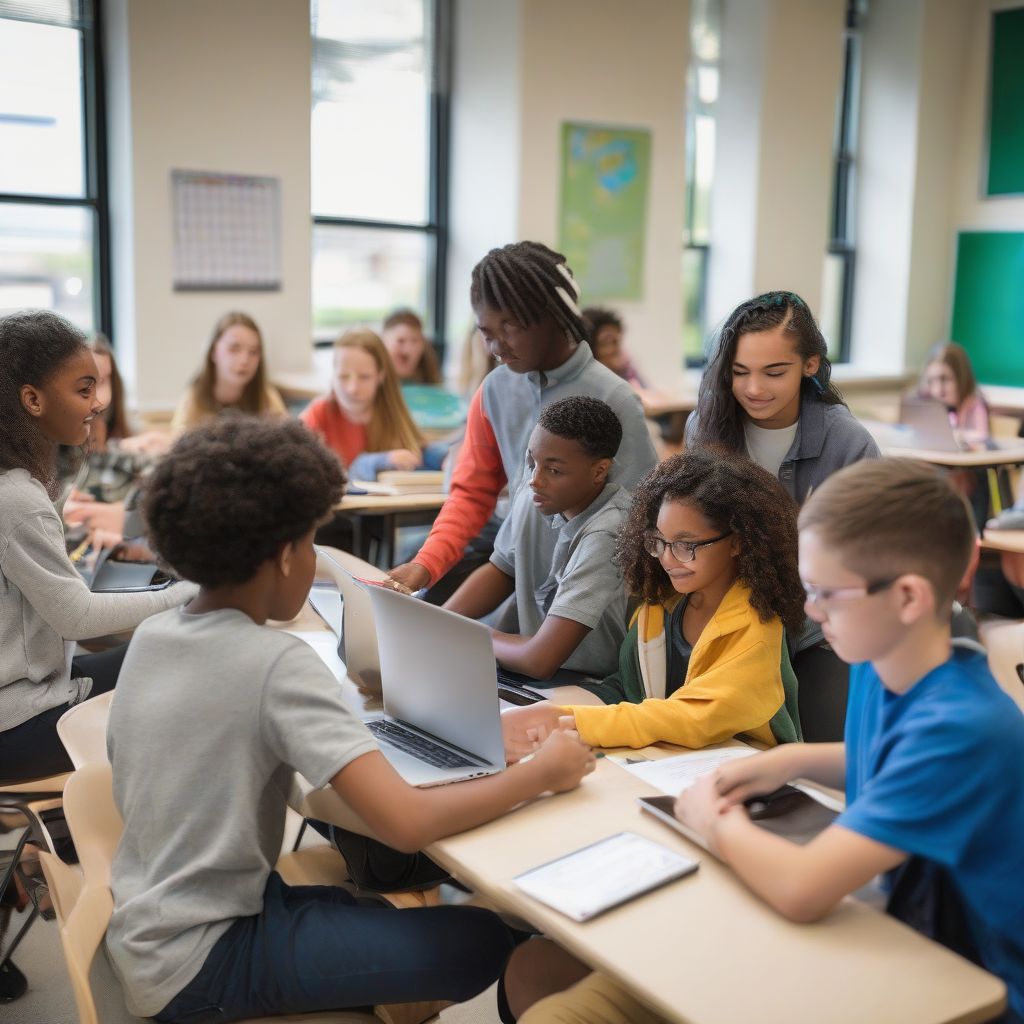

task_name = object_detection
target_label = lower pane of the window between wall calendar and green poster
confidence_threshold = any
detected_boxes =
[313,224,425,341]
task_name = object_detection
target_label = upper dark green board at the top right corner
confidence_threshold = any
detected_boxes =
[985,7,1024,196]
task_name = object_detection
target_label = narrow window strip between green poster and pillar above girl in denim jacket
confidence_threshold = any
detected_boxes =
[682,0,722,366]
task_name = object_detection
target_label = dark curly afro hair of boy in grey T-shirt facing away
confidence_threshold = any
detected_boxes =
[142,412,345,587]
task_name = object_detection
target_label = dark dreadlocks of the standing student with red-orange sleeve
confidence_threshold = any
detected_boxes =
[469,242,587,341]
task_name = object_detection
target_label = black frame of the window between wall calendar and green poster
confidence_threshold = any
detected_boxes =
[312,0,454,352]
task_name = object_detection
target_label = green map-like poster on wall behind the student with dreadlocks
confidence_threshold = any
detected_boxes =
[558,123,650,303]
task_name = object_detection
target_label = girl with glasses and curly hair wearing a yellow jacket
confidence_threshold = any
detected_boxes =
[502,449,804,760]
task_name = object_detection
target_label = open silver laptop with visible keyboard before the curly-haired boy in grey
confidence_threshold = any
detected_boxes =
[366,584,505,785]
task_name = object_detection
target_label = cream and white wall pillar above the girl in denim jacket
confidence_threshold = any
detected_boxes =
[708,0,844,327]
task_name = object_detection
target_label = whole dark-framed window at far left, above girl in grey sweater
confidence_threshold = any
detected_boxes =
[0,0,111,334]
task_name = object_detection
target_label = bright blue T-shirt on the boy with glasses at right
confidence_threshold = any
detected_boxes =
[837,650,1024,1014]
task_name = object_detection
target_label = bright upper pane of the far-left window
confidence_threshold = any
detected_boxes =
[0,18,85,196]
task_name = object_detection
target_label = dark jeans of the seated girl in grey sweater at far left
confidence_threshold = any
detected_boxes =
[0,644,128,785]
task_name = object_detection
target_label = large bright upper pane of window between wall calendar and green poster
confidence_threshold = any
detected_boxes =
[312,0,431,223]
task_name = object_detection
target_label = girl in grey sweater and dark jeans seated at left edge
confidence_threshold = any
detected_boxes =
[0,310,195,780]
